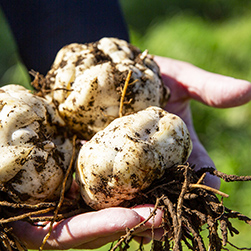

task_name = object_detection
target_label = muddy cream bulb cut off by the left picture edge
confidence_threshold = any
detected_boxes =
[0,85,72,204]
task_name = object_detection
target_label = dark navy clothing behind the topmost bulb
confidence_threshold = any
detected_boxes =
[0,0,129,74]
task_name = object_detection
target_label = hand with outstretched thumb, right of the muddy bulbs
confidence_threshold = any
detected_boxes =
[154,56,251,189]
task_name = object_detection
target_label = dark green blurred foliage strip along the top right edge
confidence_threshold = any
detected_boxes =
[120,0,251,34]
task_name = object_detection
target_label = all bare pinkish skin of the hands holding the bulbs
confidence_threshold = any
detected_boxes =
[9,56,251,249]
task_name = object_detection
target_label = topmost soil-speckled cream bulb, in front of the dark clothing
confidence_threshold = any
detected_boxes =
[46,38,169,139]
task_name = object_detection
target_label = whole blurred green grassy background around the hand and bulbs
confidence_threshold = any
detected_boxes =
[0,0,251,251]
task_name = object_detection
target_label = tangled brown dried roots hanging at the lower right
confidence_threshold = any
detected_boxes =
[111,165,251,251]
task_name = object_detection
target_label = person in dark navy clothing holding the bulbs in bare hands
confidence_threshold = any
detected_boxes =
[0,0,251,249]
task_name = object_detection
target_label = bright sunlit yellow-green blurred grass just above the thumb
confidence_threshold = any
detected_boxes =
[131,13,251,80]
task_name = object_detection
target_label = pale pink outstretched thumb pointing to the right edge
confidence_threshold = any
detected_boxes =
[155,56,251,108]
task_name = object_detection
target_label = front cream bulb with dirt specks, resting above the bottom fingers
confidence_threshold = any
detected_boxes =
[76,107,192,210]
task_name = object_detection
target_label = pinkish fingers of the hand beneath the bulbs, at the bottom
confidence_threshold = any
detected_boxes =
[11,182,163,250]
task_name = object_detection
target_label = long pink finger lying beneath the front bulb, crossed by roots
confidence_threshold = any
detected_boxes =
[10,208,141,249]
